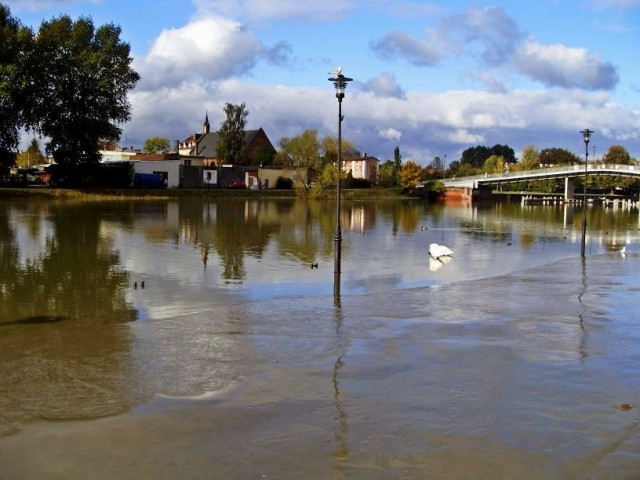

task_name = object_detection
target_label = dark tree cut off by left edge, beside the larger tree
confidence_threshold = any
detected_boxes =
[0,4,33,174]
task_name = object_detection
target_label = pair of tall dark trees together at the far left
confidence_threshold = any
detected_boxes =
[0,4,140,183]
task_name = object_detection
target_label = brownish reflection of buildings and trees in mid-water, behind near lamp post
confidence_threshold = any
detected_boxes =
[180,199,432,280]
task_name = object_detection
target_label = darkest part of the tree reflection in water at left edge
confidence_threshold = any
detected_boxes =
[0,204,135,322]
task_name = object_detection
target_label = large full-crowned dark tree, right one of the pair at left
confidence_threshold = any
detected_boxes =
[27,16,140,181]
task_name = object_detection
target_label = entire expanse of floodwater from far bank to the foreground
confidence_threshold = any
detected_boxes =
[0,200,640,480]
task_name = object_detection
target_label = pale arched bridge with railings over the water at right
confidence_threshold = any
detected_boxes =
[443,164,640,200]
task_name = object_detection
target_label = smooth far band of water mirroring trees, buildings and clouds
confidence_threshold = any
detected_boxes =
[5,199,638,314]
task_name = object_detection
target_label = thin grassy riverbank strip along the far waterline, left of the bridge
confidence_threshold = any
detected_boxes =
[0,187,406,200]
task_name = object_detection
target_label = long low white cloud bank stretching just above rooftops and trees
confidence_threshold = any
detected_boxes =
[126,75,640,165]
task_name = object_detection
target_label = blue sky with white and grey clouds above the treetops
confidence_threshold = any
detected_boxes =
[7,0,640,166]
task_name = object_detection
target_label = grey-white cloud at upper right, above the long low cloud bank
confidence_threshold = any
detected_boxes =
[369,7,619,92]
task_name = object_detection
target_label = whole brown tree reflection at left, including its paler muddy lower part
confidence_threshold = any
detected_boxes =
[0,202,140,435]
